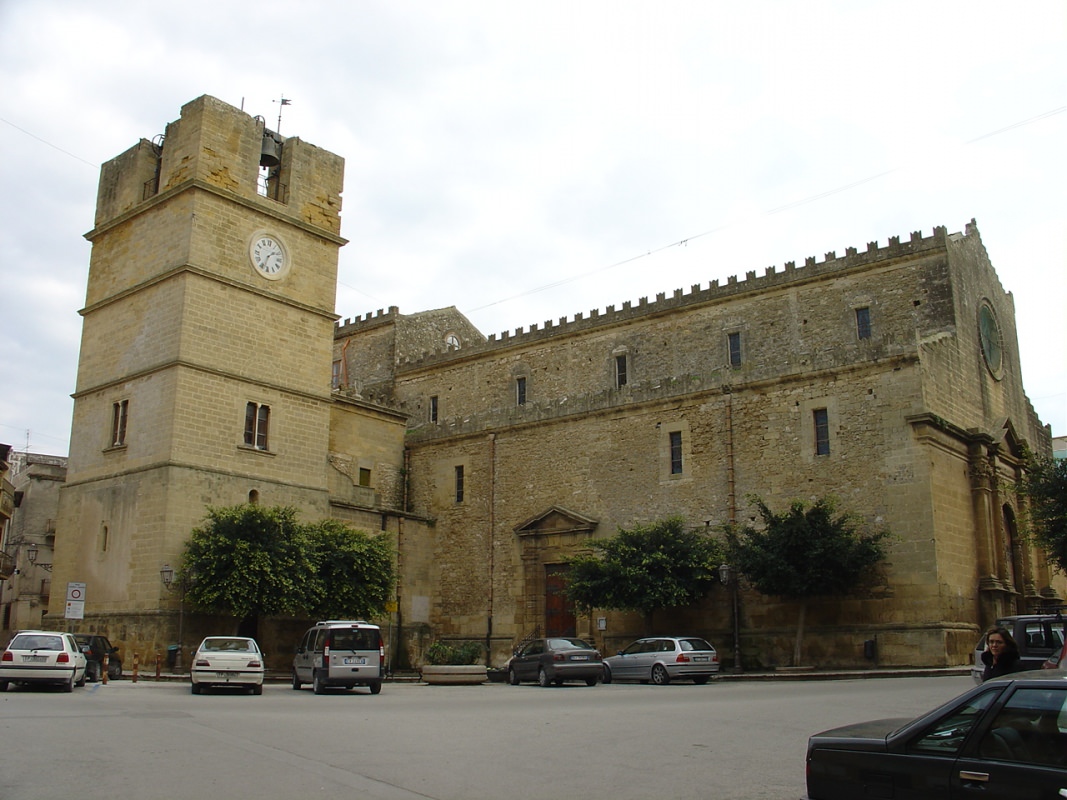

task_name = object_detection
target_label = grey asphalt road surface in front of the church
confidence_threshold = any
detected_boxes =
[0,676,973,800]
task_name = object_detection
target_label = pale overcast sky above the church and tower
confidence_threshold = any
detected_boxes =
[0,0,1067,455]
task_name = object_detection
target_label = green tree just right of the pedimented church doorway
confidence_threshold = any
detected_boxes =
[566,516,722,634]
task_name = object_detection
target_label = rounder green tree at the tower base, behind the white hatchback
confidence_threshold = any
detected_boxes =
[180,503,315,636]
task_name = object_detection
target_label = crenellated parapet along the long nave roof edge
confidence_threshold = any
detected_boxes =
[390,221,951,369]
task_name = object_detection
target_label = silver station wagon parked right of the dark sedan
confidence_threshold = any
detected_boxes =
[604,636,719,686]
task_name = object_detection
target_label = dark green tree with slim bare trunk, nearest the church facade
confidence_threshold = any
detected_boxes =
[726,497,889,666]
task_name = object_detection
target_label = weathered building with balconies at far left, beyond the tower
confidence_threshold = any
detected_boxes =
[0,452,67,637]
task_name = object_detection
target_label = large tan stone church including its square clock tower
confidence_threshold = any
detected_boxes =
[48,96,1049,669]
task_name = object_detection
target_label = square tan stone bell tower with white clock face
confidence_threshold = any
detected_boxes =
[48,96,345,647]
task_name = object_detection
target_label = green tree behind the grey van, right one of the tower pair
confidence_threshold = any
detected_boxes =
[307,519,395,619]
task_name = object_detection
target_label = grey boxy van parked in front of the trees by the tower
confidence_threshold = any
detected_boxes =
[292,620,385,694]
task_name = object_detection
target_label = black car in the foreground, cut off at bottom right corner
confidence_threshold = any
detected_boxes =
[807,670,1067,800]
